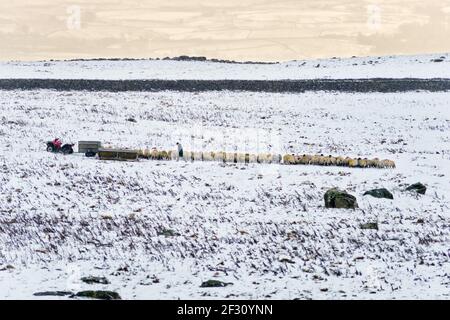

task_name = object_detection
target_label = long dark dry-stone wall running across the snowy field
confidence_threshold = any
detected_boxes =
[0,78,450,93]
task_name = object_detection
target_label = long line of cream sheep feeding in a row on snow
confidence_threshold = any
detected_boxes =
[138,149,395,168]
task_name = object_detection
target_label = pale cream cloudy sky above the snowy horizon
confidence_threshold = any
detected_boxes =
[0,0,450,61]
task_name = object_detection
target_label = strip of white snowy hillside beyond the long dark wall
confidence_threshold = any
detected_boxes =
[0,53,450,80]
